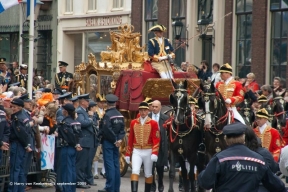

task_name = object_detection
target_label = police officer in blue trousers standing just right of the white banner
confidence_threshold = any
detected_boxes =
[56,103,82,192]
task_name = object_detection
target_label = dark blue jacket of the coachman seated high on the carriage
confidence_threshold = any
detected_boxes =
[148,37,174,57]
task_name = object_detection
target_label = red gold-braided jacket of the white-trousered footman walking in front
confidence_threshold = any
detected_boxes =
[125,117,160,156]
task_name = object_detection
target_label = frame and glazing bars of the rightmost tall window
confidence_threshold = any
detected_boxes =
[269,0,288,82]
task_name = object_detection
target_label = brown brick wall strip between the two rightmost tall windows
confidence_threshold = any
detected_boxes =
[251,0,270,85]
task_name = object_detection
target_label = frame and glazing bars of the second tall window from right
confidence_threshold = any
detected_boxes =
[235,0,253,78]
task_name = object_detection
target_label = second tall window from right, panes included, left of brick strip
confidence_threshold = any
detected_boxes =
[236,0,252,78]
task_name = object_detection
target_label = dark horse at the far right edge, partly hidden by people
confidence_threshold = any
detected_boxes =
[261,91,287,136]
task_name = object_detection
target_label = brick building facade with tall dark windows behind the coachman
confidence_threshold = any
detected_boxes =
[131,0,288,85]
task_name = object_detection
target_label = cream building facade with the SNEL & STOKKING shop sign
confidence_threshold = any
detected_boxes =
[57,0,131,72]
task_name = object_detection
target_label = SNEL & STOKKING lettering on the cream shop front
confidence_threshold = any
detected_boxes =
[86,16,122,27]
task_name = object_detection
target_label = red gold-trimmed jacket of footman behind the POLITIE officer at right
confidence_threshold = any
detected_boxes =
[254,125,284,162]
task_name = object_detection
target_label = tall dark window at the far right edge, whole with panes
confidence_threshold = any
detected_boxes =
[270,0,288,82]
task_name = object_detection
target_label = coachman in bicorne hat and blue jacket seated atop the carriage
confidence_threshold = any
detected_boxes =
[148,25,175,79]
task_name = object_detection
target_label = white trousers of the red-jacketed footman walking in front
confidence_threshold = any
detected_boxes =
[132,149,153,178]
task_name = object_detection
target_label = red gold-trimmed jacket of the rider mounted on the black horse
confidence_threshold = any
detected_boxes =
[216,79,244,106]
